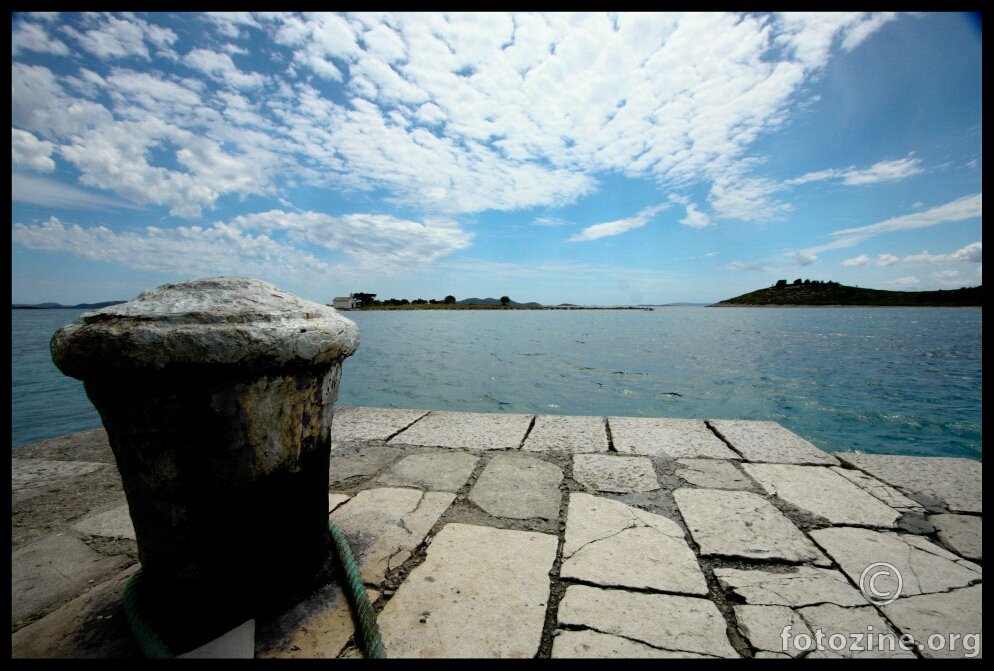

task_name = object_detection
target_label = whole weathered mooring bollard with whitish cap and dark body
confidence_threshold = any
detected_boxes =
[51,277,359,637]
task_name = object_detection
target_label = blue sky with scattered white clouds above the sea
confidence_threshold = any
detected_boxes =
[11,13,983,305]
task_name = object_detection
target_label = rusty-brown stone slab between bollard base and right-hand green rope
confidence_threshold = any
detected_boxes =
[255,582,380,659]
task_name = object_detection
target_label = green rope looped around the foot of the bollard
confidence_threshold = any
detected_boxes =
[124,522,387,659]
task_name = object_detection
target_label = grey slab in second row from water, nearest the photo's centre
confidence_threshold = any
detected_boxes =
[469,453,563,520]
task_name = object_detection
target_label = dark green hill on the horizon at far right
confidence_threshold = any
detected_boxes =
[714,280,983,307]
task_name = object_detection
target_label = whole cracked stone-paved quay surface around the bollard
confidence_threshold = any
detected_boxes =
[11,408,983,658]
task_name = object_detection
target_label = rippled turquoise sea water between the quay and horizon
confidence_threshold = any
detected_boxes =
[11,307,983,459]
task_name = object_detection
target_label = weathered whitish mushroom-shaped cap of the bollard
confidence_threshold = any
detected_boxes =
[51,277,359,380]
